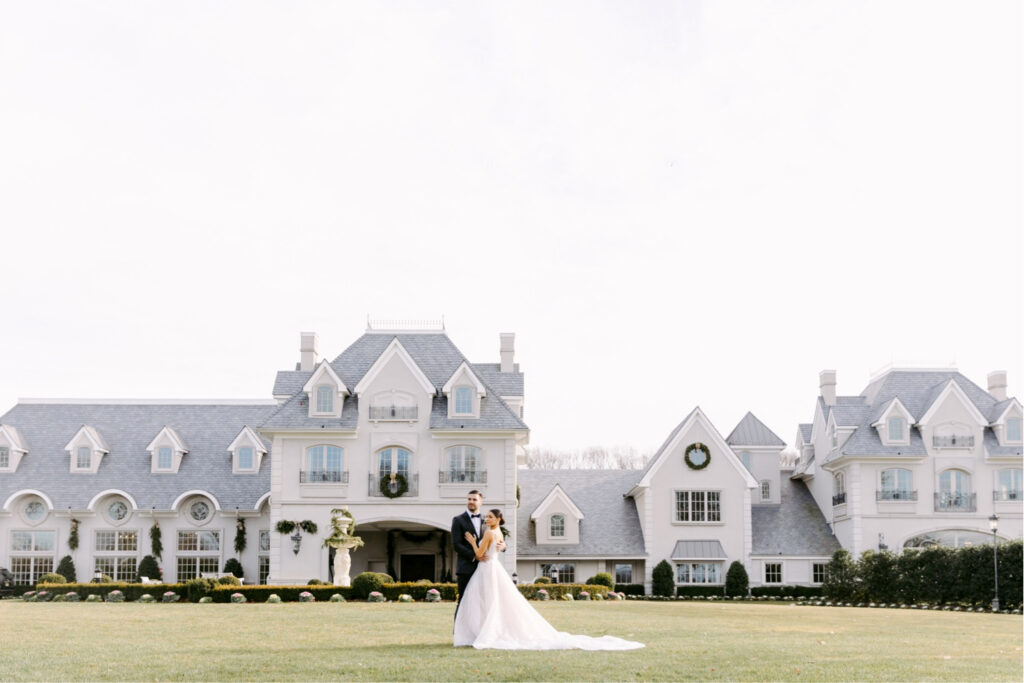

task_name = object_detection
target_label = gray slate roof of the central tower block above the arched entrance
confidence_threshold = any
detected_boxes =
[260,333,527,431]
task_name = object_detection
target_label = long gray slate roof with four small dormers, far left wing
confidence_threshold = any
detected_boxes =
[0,403,274,510]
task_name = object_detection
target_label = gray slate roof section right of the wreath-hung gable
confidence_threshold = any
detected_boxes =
[751,476,840,557]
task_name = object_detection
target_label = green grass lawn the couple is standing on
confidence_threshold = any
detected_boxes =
[0,600,1022,681]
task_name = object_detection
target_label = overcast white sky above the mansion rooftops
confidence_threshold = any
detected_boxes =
[0,0,1024,450]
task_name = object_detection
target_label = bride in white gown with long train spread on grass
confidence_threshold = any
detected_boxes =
[455,509,644,650]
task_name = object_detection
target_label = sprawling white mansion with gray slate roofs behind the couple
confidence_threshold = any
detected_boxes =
[0,327,1022,590]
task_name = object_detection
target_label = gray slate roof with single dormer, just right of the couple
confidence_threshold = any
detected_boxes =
[516,469,645,558]
